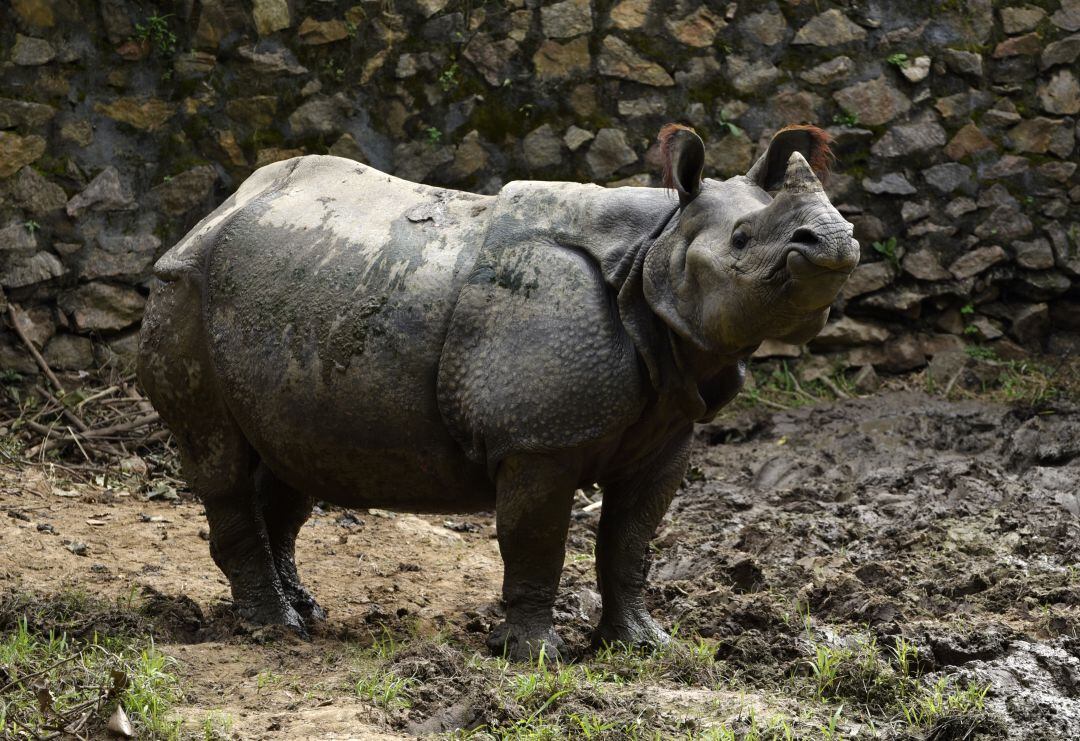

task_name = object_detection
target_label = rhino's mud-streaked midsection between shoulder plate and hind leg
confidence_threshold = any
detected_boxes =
[204,158,494,511]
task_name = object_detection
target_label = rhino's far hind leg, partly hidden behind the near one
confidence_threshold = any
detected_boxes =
[255,463,326,623]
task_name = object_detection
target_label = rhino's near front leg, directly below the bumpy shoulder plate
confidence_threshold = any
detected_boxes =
[487,455,575,661]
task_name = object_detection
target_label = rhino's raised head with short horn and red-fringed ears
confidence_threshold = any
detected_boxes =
[644,124,860,358]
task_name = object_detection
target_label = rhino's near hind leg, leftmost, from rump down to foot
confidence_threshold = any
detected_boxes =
[138,277,303,632]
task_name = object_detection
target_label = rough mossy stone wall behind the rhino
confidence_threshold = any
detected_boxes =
[0,0,1080,372]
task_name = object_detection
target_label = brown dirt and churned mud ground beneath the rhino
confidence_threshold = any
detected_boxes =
[0,391,1080,741]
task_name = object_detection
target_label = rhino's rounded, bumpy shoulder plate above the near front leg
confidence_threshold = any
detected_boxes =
[438,240,645,467]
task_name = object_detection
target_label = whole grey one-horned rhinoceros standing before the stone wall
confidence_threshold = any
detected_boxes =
[138,124,860,658]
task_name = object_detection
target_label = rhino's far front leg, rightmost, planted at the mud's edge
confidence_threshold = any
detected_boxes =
[594,429,692,647]
